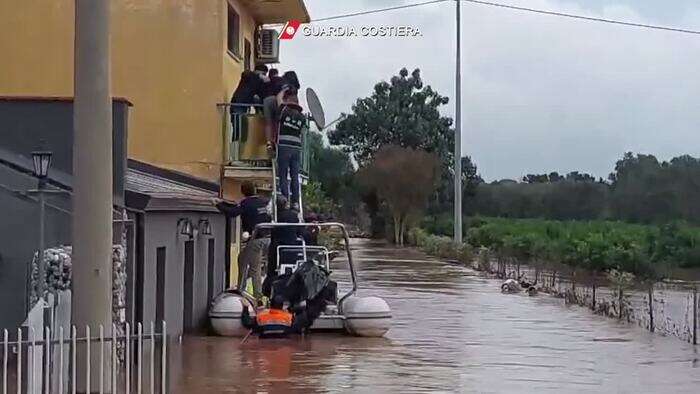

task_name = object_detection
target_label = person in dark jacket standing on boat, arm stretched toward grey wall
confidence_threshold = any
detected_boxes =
[215,181,271,299]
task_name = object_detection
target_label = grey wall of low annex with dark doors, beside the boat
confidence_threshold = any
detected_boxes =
[141,212,226,335]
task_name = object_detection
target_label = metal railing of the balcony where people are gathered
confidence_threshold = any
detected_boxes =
[218,103,310,175]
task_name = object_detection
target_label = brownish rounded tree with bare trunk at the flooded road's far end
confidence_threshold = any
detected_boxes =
[360,145,438,246]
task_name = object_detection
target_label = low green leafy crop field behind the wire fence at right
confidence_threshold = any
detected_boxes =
[413,218,700,280]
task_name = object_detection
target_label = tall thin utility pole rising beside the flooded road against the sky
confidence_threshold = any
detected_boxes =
[454,0,462,244]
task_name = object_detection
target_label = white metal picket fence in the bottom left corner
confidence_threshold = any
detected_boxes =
[0,322,168,394]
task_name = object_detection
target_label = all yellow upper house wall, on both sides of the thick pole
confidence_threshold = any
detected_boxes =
[0,0,256,181]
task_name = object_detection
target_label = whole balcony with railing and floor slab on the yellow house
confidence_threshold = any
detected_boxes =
[218,103,310,181]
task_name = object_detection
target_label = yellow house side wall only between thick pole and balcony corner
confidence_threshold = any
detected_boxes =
[112,0,225,181]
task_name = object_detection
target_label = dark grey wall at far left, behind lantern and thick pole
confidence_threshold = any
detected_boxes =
[0,100,128,331]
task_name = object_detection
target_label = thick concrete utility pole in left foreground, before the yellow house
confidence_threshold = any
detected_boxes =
[72,0,113,392]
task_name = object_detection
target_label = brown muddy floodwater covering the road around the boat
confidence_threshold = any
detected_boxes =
[171,241,700,394]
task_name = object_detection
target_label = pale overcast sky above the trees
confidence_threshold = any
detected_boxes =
[280,0,700,180]
